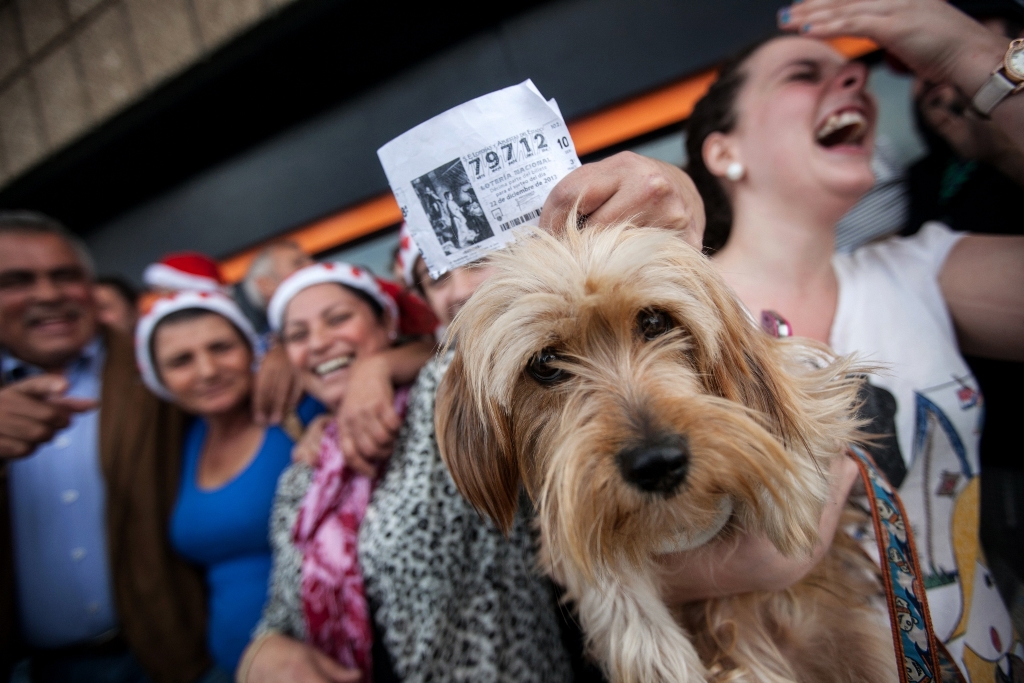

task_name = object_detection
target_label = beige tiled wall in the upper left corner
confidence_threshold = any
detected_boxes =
[0,0,293,186]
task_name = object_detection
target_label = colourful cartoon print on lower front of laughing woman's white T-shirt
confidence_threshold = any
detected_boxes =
[900,376,1024,683]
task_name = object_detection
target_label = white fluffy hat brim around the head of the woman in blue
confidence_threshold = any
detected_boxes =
[135,292,261,400]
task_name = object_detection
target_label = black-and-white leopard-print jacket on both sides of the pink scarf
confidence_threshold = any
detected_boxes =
[256,354,572,683]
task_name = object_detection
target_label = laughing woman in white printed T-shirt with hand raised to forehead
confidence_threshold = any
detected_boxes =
[676,0,1024,680]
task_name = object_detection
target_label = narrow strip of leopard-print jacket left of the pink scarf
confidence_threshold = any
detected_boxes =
[253,463,313,640]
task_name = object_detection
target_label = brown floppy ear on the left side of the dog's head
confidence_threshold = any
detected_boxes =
[434,350,519,533]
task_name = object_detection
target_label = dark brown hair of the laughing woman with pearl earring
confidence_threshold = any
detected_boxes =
[685,33,785,252]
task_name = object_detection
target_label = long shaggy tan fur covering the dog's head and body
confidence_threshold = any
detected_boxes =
[436,223,894,683]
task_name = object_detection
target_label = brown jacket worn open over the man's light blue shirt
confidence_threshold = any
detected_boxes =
[0,331,211,683]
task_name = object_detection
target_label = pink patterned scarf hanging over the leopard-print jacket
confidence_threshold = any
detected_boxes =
[293,387,409,682]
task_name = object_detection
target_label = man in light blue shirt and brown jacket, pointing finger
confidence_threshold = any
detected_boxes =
[0,212,209,683]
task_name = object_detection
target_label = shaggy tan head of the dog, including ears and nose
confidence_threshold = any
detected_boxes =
[436,225,856,574]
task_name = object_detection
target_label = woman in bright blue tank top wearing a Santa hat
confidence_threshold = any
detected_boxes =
[135,292,293,680]
